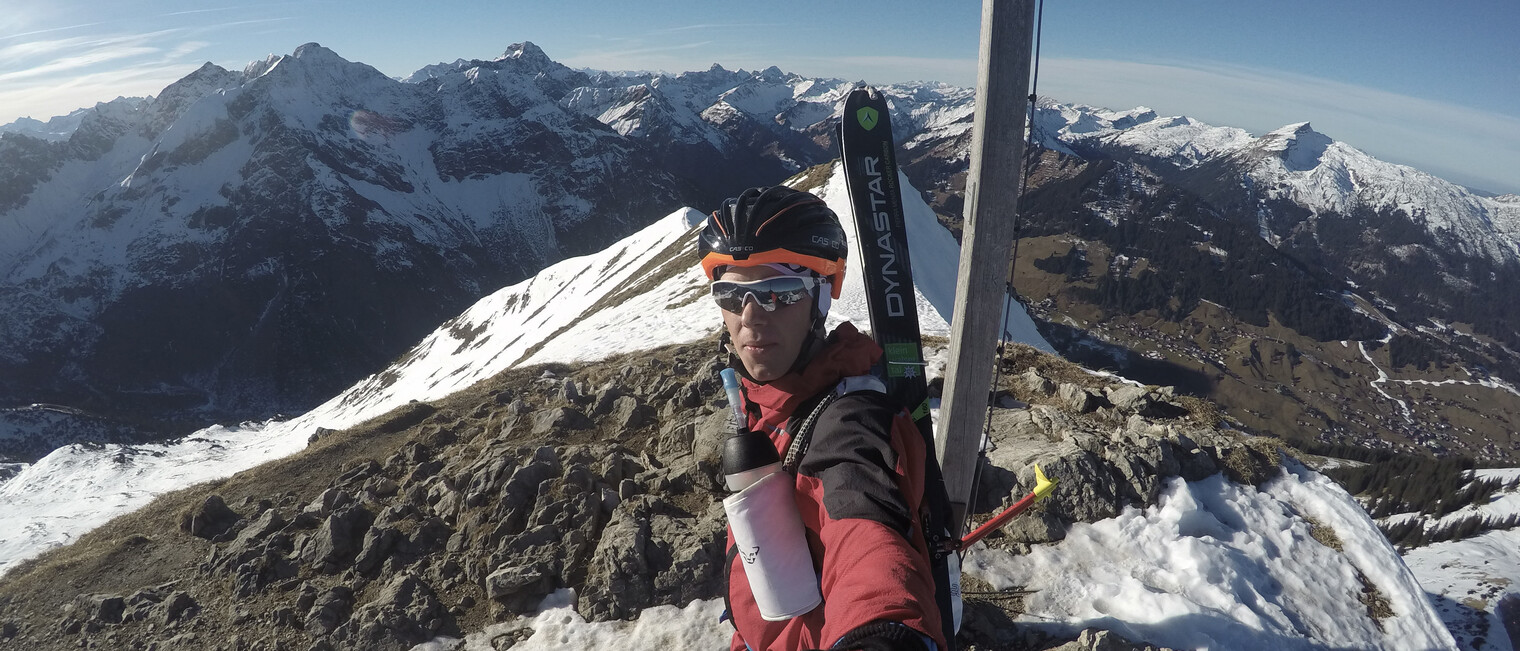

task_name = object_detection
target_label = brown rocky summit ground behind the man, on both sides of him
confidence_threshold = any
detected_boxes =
[0,341,1313,649]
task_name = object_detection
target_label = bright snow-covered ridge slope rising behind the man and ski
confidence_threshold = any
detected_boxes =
[0,165,1052,569]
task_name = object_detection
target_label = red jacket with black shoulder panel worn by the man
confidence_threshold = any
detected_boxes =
[727,322,945,651]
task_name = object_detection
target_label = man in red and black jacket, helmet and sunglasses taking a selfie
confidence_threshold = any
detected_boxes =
[699,187,945,651]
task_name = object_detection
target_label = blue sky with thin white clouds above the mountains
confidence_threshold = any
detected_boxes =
[0,0,1520,192]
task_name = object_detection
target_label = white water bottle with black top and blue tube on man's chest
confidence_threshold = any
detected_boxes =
[722,368,824,622]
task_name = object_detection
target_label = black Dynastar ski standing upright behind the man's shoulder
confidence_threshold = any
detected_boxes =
[839,87,959,649]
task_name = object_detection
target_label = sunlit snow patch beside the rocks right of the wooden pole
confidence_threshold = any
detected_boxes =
[967,464,1455,649]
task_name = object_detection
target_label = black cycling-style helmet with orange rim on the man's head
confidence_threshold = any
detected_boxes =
[698,186,847,298]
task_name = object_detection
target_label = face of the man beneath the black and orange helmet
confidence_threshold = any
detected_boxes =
[719,266,813,382]
